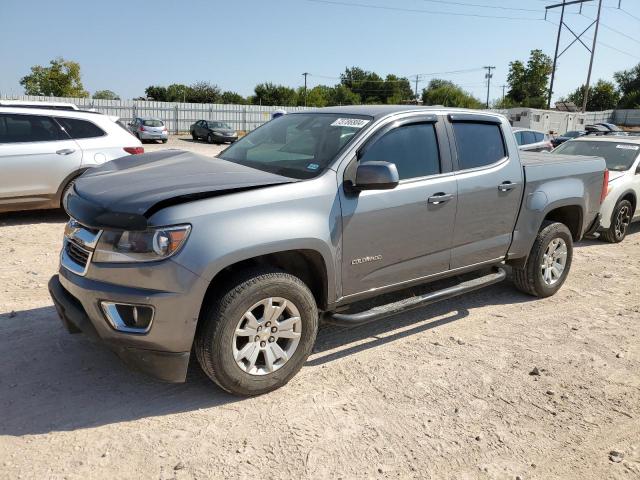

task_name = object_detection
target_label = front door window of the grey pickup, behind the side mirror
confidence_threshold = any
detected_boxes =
[360,123,440,180]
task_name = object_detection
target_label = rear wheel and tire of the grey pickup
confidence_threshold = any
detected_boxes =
[513,221,573,298]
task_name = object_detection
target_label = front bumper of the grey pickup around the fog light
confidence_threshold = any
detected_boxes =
[49,268,197,383]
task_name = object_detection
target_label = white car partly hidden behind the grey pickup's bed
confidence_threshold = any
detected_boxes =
[553,135,640,243]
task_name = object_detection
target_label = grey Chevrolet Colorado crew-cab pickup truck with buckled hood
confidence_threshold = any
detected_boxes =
[49,106,607,395]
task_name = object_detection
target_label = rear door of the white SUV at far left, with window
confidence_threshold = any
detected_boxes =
[0,113,82,203]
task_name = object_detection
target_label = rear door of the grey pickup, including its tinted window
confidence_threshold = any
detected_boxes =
[448,113,523,269]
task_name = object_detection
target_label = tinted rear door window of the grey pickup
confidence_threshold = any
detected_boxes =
[453,122,508,170]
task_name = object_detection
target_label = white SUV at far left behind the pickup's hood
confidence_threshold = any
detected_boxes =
[0,109,144,212]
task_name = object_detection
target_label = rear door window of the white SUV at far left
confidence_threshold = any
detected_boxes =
[0,113,67,143]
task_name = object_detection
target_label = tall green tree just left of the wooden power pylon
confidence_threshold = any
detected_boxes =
[507,50,553,108]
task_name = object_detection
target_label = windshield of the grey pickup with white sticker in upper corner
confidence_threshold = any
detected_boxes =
[219,113,372,179]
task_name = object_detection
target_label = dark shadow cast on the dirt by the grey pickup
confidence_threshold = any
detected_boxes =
[0,274,531,436]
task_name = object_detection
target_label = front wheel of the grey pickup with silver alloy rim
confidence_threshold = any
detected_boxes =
[194,269,318,396]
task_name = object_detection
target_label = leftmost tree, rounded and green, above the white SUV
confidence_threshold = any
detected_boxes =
[20,57,89,98]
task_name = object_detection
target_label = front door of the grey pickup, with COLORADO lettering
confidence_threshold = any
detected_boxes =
[340,115,457,296]
